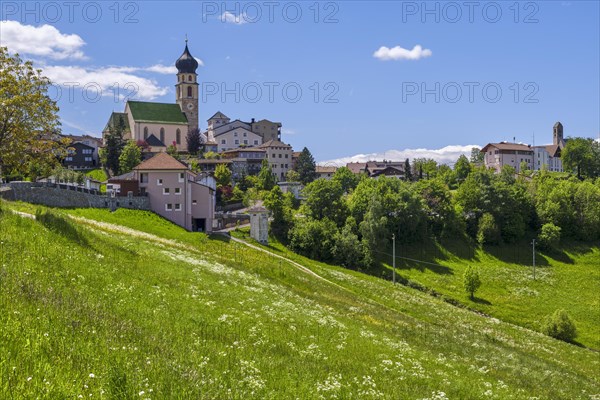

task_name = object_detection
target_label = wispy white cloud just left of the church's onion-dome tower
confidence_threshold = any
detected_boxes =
[42,66,169,100]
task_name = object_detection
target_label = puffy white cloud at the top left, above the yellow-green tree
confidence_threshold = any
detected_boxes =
[0,21,86,60]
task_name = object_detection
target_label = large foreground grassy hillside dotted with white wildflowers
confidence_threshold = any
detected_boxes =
[0,202,600,399]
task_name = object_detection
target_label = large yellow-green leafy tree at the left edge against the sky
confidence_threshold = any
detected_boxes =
[0,47,62,176]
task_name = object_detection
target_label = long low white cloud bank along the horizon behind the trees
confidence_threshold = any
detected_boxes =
[318,144,481,166]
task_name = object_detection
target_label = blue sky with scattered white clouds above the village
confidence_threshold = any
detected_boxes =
[0,1,600,161]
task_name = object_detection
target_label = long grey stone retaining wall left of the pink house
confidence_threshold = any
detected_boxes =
[0,182,150,210]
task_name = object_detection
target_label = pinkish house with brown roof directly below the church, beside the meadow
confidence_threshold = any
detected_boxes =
[134,153,215,232]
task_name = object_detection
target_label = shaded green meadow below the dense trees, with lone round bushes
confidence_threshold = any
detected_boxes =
[234,230,600,350]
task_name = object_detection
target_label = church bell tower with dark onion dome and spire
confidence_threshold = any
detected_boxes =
[175,35,199,134]
